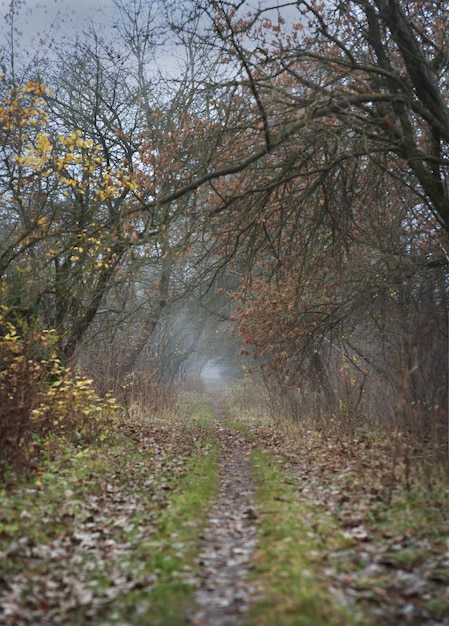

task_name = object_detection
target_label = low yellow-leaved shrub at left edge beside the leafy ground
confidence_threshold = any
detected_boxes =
[0,307,118,478]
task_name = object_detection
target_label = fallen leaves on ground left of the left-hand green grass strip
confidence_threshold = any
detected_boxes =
[0,420,212,626]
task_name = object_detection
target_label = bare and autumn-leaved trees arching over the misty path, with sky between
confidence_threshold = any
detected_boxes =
[0,0,449,454]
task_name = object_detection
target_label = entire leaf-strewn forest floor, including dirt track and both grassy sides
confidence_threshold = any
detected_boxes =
[0,394,449,626]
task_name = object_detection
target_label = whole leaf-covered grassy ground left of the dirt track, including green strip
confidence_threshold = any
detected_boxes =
[0,406,218,626]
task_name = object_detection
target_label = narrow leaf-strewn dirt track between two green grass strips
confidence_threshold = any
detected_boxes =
[191,410,257,626]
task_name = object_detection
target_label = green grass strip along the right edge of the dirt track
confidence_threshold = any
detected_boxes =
[248,450,361,626]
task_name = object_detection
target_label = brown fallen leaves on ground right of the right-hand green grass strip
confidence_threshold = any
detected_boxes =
[245,425,449,626]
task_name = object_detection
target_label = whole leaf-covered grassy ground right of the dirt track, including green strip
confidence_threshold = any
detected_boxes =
[223,382,449,626]
